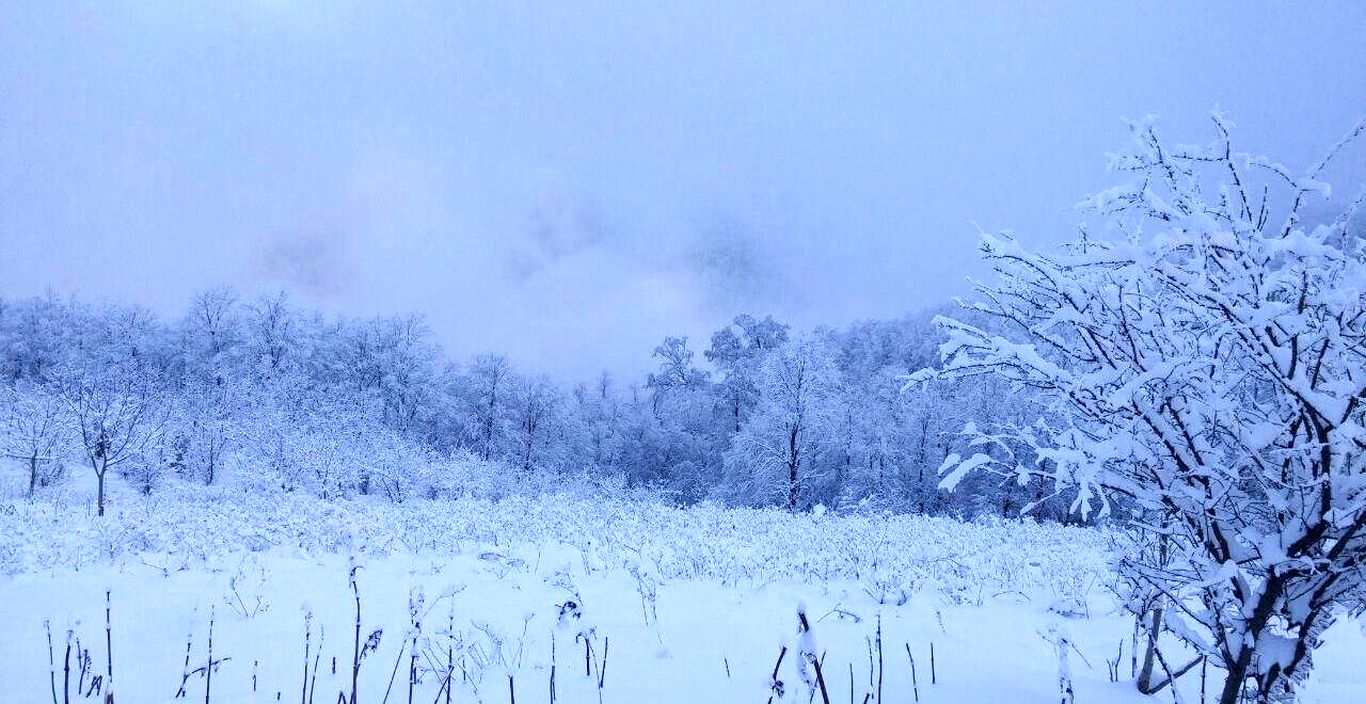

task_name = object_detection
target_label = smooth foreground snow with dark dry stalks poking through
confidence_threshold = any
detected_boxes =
[8,552,1142,703]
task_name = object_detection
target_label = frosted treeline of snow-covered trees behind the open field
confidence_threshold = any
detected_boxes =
[0,288,1065,517]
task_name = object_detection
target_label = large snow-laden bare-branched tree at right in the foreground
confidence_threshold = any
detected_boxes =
[922,115,1366,703]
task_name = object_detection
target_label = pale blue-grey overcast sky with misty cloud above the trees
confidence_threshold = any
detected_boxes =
[0,0,1366,377]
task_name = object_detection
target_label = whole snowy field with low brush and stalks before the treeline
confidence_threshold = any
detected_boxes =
[0,470,1366,704]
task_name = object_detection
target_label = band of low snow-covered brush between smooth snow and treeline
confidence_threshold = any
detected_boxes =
[0,487,1115,603]
